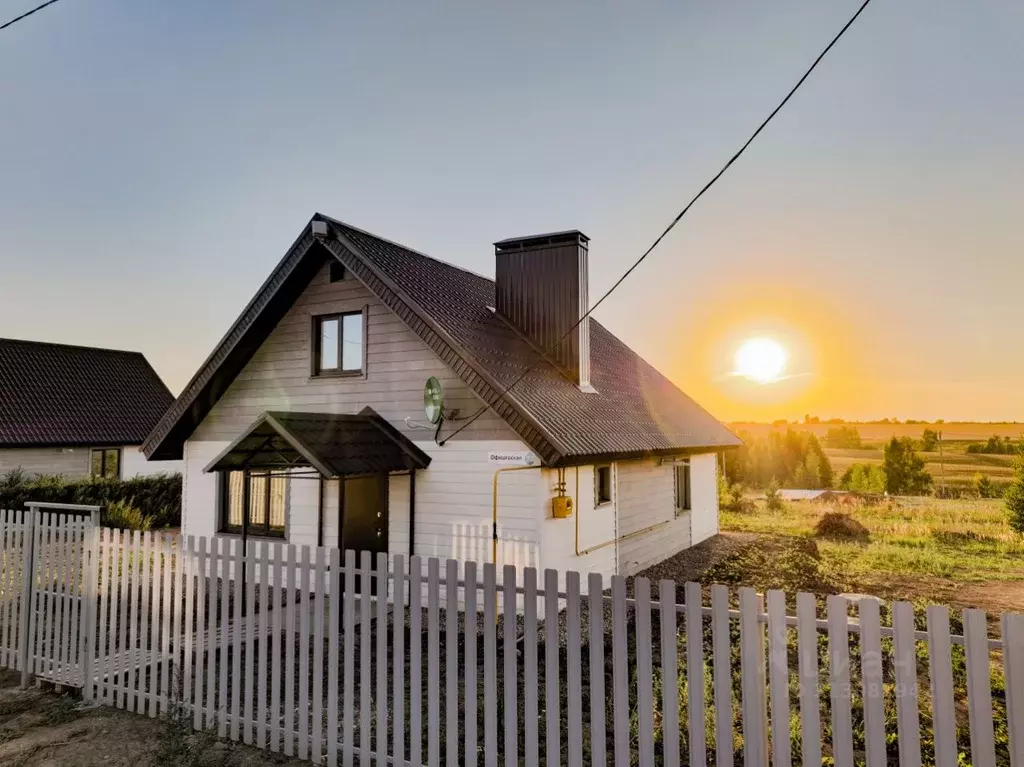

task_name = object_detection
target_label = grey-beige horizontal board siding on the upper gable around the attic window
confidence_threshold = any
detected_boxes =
[189,266,518,441]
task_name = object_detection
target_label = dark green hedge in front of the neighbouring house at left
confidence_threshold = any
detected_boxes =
[0,474,181,527]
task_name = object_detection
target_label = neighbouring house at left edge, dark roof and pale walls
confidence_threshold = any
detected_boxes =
[0,338,182,479]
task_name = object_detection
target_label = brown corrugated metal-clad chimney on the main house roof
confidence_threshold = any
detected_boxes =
[495,229,593,391]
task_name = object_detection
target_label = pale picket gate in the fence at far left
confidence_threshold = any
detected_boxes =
[18,503,99,687]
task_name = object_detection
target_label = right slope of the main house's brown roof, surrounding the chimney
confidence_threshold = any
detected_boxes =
[333,222,739,459]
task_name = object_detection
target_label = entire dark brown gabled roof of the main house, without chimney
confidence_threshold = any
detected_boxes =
[143,214,740,466]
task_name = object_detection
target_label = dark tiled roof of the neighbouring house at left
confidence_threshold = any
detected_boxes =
[0,339,174,448]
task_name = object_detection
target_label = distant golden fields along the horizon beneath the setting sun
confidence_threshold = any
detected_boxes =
[729,423,1024,488]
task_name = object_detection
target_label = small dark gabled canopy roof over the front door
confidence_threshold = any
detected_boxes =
[205,408,430,478]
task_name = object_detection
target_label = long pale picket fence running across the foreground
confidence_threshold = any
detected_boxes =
[0,512,1024,767]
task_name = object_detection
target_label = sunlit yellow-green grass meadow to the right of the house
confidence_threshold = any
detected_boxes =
[722,499,1024,584]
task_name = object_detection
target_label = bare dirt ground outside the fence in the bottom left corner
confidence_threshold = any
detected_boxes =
[0,672,306,767]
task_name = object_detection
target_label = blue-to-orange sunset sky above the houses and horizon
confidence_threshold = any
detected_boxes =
[0,0,1024,420]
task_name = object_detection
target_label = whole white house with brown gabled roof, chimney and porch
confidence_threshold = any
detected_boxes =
[143,214,739,574]
